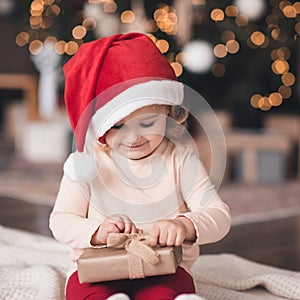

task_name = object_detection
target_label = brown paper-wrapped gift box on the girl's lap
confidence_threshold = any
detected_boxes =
[77,247,182,283]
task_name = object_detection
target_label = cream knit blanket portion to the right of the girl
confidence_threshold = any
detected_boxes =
[192,254,300,300]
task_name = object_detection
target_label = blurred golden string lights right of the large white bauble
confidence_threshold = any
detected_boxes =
[210,0,300,111]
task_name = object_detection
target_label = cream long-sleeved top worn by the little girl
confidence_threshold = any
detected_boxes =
[50,140,231,273]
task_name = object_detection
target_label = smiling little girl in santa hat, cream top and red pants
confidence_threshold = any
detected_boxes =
[50,33,230,300]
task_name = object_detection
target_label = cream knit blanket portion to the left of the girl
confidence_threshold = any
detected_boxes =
[0,226,69,300]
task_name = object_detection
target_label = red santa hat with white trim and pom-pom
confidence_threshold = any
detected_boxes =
[64,33,183,182]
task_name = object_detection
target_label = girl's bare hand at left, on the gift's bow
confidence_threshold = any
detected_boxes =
[91,214,137,245]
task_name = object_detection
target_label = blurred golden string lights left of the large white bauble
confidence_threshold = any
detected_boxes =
[16,0,183,76]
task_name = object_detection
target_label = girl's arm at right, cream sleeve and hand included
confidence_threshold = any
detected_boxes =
[149,148,231,246]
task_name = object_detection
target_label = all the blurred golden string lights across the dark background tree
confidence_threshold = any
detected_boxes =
[16,0,300,111]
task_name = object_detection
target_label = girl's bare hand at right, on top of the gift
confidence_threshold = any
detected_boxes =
[149,217,196,247]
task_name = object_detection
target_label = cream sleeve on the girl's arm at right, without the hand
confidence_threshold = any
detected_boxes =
[179,153,231,244]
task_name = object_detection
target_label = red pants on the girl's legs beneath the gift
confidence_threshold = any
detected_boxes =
[66,267,195,300]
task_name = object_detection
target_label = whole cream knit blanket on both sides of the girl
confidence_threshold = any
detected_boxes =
[0,226,300,300]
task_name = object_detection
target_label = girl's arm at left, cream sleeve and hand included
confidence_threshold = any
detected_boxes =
[50,177,137,248]
